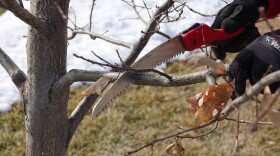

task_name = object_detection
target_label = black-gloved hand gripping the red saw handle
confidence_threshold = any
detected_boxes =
[211,0,269,60]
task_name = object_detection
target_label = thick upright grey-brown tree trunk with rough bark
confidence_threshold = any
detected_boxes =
[24,0,69,156]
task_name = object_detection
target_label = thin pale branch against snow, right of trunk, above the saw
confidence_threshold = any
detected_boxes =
[68,30,133,49]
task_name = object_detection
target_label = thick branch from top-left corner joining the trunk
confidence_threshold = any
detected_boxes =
[0,0,48,32]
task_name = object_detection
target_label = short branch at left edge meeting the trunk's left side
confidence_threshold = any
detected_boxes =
[0,48,26,91]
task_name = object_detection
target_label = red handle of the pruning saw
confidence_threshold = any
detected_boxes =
[181,23,245,51]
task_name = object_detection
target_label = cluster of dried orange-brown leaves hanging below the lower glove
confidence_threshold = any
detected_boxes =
[186,83,233,126]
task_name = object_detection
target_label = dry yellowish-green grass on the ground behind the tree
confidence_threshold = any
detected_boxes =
[0,11,280,156]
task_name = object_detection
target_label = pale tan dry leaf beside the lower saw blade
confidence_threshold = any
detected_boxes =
[82,77,111,96]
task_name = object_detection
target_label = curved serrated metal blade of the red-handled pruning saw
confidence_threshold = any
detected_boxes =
[92,36,185,117]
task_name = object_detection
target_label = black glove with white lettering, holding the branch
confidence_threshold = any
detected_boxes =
[228,30,280,95]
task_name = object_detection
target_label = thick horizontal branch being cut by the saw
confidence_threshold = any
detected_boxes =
[53,65,225,92]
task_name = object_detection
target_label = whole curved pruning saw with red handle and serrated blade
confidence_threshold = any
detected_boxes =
[92,23,245,117]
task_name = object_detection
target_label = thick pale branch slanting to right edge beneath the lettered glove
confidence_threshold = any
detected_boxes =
[220,71,280,119]
